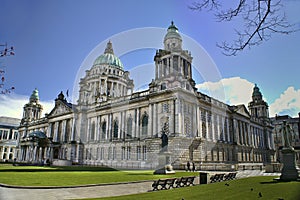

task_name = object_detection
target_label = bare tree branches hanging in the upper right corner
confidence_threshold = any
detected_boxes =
[190,0,298,56]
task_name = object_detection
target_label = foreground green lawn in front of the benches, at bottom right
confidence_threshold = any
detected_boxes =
[82,176,300,200]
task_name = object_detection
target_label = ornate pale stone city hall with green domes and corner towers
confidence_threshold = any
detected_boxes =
[17,22,275,169]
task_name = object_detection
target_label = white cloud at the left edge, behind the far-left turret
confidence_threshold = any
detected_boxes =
[0,93,54,119]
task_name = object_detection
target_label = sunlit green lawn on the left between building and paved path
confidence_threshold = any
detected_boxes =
[0,165,198,186]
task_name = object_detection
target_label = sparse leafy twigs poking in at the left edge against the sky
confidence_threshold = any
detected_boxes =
[0,44,15,94]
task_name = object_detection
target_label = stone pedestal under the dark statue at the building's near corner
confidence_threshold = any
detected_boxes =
[154,152,175,174]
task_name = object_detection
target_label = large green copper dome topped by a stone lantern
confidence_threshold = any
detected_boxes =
[93,41,124,70]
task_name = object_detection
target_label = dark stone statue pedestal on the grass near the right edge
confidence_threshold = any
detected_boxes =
[279,147,299,181]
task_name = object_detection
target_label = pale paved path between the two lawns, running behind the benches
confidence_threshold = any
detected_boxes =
[0,170,280,200]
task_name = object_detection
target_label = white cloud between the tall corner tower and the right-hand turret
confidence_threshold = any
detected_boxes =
[196,77,254,105]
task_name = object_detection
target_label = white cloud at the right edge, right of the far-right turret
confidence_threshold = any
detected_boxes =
[270,87,300,117]
